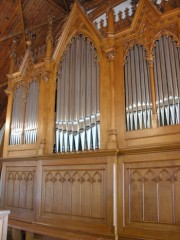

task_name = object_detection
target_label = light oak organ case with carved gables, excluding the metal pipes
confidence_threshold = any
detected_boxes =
[1,0,180,240]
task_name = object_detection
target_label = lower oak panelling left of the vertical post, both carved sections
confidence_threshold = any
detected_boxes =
[1,157,114,239]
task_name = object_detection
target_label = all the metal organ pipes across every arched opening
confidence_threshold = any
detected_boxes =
[10,35,180,145]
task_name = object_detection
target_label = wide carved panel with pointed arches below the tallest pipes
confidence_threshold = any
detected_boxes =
[42,165,106,220]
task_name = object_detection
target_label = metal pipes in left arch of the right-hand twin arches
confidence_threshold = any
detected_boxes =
[124,45,152,131]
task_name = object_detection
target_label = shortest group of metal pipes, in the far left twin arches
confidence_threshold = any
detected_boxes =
[10,80,39,145]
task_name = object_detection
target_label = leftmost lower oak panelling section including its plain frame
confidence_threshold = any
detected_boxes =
[1,162,36,221]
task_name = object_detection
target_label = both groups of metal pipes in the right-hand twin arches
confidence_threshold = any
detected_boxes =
[124,36,180,131]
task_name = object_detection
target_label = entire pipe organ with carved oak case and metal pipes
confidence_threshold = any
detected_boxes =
[0,0,180,240]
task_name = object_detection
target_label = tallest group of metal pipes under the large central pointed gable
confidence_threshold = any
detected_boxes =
[55,35,100,152]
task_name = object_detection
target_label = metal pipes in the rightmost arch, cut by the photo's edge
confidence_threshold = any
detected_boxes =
[154,36,180,126]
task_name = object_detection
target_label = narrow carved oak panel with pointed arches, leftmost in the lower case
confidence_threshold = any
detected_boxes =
[5,167,35,210]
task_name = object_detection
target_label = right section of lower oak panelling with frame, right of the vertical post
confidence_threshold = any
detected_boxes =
[118,152,180,240]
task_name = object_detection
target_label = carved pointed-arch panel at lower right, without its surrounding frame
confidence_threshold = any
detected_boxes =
[125,163,180,225]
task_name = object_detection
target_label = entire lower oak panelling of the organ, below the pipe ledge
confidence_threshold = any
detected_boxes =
[1,149,180,240]
